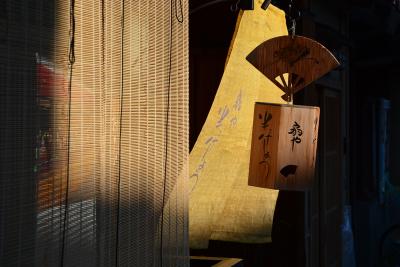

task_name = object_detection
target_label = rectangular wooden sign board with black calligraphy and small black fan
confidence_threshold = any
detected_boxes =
[248,103,319,191]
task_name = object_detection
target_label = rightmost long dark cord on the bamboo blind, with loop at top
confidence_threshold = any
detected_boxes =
[160,0,184,267]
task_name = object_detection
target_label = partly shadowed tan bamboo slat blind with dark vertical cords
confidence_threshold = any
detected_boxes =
[0,0,189,266]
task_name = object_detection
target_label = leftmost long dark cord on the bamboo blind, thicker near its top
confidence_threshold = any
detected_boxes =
[60,0,75,267]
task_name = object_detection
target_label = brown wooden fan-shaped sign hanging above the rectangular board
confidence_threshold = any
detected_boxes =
[246,36,340,102]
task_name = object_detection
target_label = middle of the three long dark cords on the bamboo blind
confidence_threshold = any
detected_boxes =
[115,0,125,267]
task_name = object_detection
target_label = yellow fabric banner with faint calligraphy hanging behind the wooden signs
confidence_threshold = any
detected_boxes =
[189,0,287,249]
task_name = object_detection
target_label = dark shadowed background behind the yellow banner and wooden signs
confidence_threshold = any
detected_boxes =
[190,0,400,267]
